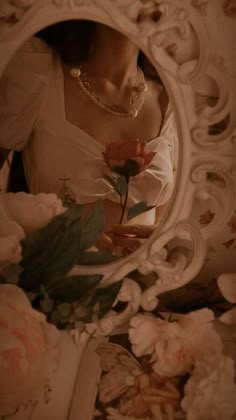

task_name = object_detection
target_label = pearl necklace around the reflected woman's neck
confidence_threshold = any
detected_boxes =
[70,66,147,118]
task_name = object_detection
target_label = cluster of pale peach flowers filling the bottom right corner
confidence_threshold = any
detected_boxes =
[94,302,236,420]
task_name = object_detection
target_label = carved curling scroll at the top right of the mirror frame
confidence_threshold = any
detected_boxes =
[144,2,209,84]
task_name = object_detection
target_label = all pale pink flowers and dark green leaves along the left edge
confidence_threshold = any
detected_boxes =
[0,192,125,415]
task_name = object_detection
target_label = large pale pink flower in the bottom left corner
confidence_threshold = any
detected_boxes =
[0,284,59,415]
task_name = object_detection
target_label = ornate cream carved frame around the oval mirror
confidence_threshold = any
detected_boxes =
[0,0,236,332]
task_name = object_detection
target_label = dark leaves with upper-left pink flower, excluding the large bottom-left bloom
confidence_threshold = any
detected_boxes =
[0,193,122,329]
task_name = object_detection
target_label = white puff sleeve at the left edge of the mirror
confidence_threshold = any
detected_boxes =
[0,38,53,151]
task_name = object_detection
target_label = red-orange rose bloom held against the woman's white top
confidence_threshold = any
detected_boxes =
[103,139,155,177]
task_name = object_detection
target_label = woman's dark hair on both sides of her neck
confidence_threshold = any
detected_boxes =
[35,20,161,83]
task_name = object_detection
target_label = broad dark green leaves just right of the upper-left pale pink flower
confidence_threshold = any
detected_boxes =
[20,202,104,291]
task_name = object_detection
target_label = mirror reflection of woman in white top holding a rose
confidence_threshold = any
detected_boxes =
[0,20,177,255]
